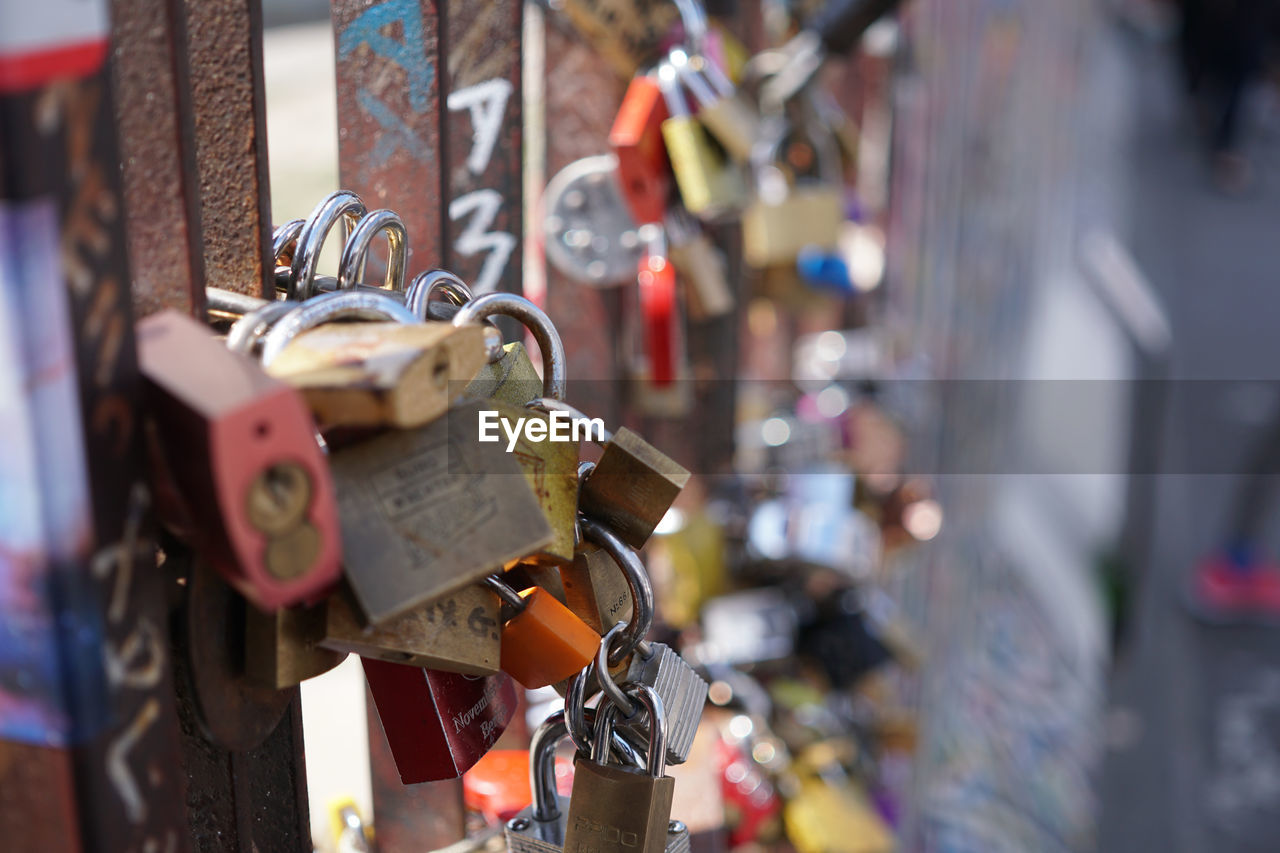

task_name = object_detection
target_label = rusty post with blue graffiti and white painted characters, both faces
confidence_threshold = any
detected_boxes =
[332,0,522,835]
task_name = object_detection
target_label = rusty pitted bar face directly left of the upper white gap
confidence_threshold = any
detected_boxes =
[179,0,274,296]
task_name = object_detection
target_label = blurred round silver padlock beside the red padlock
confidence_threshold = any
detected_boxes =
[543,154,644,287]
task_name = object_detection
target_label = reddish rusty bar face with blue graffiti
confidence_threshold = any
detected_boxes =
[332,0,445,278]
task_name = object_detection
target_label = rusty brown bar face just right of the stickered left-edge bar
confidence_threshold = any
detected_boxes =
[111,0,205,318]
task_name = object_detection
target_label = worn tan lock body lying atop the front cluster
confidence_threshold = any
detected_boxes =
[268,317,485,429]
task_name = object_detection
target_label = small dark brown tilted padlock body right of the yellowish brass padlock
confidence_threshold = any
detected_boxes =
[579,427,690,548]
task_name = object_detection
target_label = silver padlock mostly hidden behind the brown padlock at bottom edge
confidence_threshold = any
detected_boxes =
[503,708,655,853]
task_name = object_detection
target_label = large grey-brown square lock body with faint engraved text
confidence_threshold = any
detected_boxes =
[330,402,553,626]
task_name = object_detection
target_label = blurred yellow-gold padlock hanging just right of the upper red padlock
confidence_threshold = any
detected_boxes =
[658,63,745,219]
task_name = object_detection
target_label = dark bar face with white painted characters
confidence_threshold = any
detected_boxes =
[440,0,524,293]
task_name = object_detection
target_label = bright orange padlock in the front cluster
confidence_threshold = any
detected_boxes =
[485,575,600,690]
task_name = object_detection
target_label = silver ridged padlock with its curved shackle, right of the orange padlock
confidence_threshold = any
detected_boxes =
[579,516,709,765]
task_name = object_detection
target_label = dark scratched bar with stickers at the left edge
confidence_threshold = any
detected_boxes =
[0,13,188,852]
